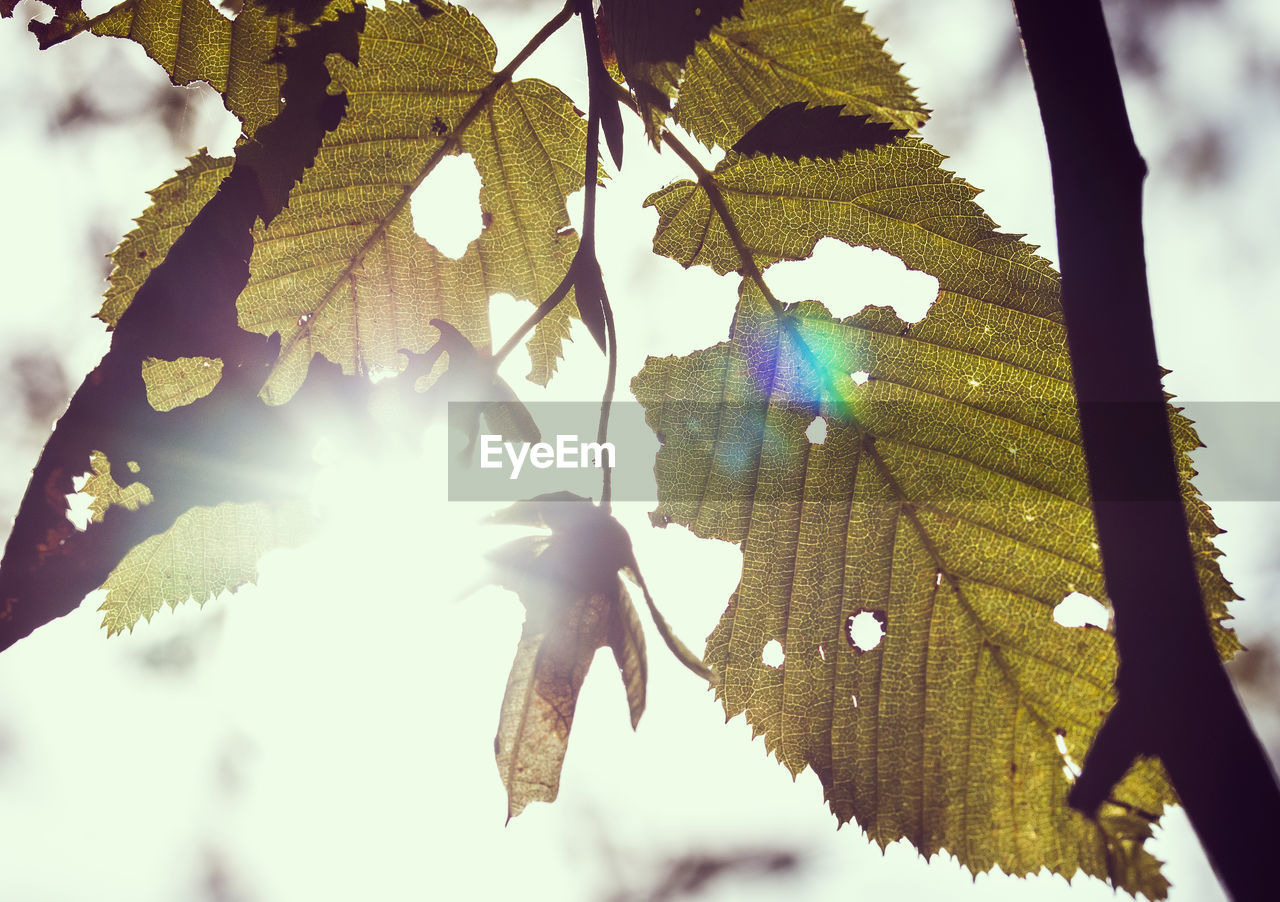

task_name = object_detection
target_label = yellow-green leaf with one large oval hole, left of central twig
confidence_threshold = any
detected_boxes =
[239,3,586,403]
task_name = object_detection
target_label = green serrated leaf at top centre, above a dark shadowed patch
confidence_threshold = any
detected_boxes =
[675,0,928,147]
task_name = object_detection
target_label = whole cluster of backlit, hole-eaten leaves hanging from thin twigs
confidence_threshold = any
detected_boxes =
[0,0,1238,897]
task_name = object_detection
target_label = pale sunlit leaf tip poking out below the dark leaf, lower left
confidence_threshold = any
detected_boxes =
[99,504,311,636]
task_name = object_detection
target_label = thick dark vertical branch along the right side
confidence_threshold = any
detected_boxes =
[1014,0,1280,899]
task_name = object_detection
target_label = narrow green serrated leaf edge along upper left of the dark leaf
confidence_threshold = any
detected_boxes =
[96,150,233,329]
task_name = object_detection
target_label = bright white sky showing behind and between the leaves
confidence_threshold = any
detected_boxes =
[0,0,1280,902]
